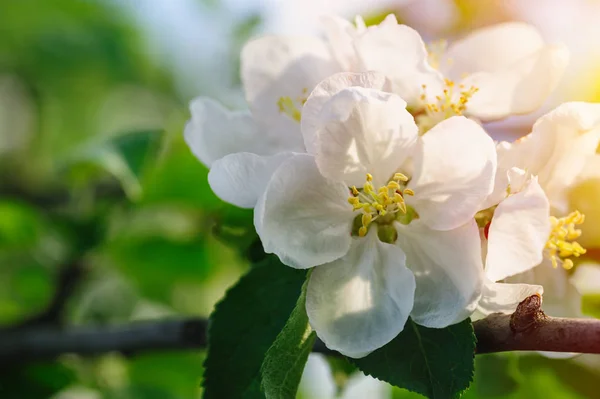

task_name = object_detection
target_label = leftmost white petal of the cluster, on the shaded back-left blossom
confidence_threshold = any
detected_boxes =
[184,97,264,167]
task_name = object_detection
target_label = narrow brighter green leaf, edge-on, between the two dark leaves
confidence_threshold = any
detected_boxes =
[261,284,316,398]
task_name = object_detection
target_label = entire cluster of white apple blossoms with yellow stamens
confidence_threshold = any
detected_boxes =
[185,15,600,358]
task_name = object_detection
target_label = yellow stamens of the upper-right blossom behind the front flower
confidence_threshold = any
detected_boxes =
[415,79,479,134]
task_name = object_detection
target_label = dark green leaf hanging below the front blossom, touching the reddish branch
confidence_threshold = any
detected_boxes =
[355,319,475,399]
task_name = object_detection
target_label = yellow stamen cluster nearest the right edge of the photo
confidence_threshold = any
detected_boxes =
[546,211,586,270]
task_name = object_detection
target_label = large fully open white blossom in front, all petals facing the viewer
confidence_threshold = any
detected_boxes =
[255,73,496,357]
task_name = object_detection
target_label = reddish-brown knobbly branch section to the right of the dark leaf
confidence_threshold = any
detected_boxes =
[473,295,600,354]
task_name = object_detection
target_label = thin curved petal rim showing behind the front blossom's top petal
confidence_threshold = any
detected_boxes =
[302,72,391,155]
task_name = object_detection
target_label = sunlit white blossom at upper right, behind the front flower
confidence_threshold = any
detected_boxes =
[325,15,569,126]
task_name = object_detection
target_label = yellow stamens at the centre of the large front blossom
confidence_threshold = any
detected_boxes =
[348,173,415,237]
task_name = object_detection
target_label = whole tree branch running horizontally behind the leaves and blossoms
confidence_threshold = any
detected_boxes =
[0,295,600,365]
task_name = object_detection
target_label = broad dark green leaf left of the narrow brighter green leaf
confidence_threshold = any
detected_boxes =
[203,256,306,399]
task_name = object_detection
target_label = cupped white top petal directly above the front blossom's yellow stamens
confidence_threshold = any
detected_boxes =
[304,83,418,187]
